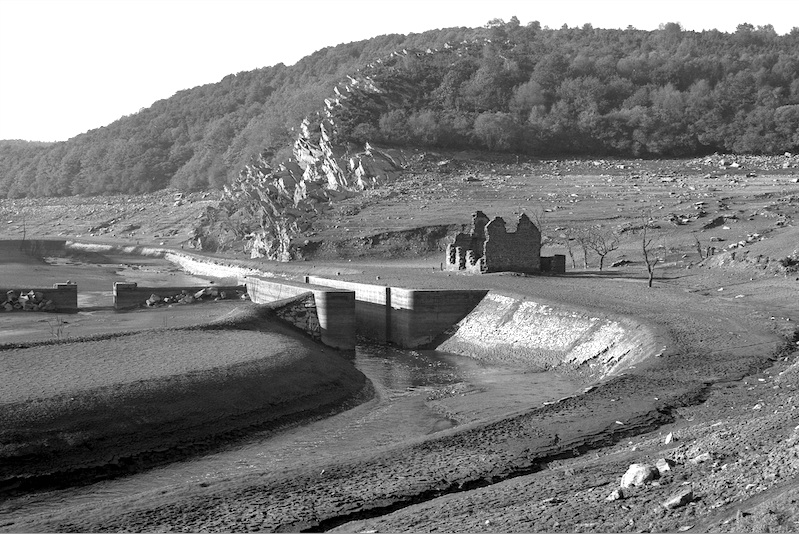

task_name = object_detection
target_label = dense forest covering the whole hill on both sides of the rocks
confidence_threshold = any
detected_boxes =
[0,17,799,198]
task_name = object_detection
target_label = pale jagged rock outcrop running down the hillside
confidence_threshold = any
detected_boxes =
[192,78,406,261]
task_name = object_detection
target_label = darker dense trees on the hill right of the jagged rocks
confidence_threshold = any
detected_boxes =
[338,21,799,157]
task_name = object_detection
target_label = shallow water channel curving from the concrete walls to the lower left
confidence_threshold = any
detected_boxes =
[0,345,578,519]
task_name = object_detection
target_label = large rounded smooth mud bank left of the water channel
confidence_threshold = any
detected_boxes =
[0,305,366,489]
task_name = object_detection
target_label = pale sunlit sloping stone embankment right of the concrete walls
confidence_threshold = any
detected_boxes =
[438,291,657,381]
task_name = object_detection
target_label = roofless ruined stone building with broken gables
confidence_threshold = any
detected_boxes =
[446,211,566,274]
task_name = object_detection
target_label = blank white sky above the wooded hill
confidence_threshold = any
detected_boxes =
[0,0,799,141]
